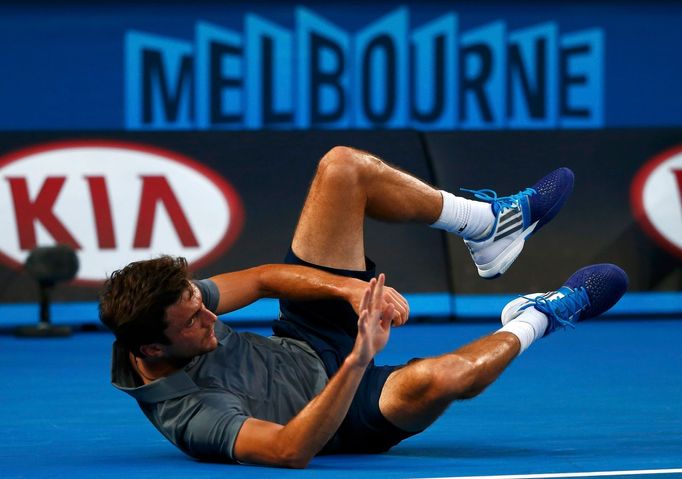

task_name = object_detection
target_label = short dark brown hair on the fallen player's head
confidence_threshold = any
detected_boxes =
[99,256,192,356]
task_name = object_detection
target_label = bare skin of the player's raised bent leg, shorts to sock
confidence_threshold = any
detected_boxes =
[292,147,443,270]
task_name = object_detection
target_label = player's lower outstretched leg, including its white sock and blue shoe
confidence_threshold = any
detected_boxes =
[379,264,628,431]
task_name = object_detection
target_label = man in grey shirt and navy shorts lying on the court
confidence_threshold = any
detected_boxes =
[100,147,627,468]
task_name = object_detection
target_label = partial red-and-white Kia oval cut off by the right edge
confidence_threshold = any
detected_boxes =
[630,146,682,257]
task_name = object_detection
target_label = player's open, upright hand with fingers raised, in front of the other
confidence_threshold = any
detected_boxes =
[349,273,396,367]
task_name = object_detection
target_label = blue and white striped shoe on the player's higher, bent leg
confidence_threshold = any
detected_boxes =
[462,168,574,279]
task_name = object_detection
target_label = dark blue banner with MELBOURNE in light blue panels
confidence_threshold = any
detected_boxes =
[0,2,682,130]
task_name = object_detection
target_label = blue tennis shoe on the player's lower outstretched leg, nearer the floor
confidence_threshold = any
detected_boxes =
[501,264,628,336]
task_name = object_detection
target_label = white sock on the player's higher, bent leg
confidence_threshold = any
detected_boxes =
[431,190,495,239]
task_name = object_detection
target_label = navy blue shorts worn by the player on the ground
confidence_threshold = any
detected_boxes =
[272,250,416,453]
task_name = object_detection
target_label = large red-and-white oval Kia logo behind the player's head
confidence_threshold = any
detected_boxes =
[0,140,243,282]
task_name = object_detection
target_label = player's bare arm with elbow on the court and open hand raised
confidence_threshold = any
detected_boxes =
[233,275,395,468]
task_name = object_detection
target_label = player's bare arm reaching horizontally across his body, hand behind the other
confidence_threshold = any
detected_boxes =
[210,264,410,325]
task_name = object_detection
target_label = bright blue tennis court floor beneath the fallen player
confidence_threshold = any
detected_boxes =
[0,318,682,479]
